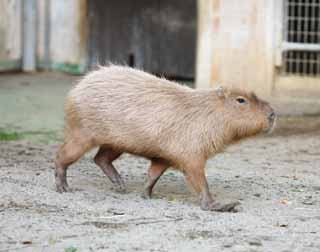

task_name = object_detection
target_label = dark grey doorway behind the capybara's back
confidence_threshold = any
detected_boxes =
[88,0,197,78]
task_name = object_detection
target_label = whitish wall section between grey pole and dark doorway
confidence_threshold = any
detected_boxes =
[49,0,87,73]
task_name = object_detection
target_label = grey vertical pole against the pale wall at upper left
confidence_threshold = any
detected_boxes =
[22,0,37,72]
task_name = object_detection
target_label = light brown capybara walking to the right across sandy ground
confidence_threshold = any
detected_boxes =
[55,66,275,211]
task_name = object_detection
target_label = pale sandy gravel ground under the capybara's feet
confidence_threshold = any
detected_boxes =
[0,118,320,252]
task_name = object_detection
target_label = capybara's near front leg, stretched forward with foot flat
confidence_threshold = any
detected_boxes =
[185,167,239,212]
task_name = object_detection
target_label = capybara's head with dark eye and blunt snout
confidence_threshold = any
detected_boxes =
[216,87,276,138]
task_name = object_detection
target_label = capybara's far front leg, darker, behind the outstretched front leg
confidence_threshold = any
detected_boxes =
[142,159,169,198]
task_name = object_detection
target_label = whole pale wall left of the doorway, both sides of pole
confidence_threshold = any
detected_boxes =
[0,0,87,73]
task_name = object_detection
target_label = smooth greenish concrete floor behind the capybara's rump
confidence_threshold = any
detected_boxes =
[0,73,81,143]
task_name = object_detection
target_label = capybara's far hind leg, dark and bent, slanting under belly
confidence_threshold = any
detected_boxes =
[94,146,126,192]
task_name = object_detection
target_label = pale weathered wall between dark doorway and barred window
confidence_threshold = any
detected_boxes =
[197,0,274,96]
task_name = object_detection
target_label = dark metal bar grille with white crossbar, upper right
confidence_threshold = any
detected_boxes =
[282,0,320,77]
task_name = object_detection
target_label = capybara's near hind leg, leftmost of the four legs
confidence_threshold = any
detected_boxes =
[55,140,90,193]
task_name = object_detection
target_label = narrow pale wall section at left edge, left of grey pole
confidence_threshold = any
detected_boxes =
[0,0,22,71]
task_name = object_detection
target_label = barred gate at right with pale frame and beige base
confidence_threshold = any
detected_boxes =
[275,0,320,96]
